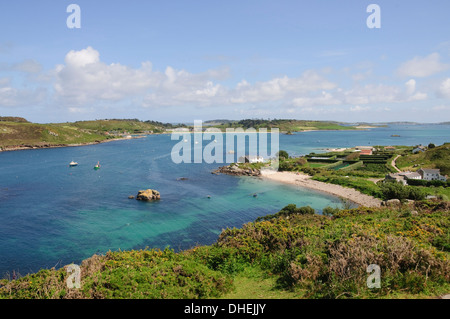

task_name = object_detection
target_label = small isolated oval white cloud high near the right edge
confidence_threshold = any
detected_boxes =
[397,53,450,78]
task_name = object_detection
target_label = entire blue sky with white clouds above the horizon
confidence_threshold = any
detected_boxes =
[0,0,450,123]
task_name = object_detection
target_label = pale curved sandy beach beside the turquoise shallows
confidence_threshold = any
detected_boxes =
[261,170,381,207]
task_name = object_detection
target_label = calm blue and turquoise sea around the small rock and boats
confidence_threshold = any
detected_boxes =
[0,125,450,278]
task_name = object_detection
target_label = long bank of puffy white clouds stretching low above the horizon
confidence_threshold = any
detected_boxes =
[0,47,442,120]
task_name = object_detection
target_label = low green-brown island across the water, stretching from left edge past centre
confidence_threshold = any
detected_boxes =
[0,116,367,151]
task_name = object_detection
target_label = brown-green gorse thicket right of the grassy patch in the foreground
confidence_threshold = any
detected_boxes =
[218,205,450,298]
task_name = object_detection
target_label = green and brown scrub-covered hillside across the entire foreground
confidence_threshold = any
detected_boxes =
[0,201,450,299]
